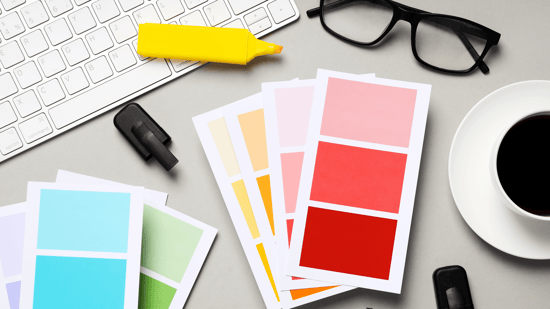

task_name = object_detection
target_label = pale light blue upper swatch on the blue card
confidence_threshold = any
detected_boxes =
[37,189,130,253]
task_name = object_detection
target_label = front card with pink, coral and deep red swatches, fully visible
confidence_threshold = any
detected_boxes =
[287,70,431,293]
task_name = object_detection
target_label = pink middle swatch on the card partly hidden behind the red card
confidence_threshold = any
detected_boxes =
[281,152,304,213]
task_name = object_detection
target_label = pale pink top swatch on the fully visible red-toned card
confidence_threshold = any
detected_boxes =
[321,77,416,147]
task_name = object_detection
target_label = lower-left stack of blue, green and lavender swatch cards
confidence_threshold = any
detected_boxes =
[0,171,217,309]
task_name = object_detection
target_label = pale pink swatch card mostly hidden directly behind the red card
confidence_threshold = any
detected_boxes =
[262,74,374,289]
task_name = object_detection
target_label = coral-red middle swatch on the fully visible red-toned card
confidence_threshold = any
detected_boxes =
[310,142,407,213]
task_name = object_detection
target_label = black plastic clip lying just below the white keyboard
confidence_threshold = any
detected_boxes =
[114,103,178,171]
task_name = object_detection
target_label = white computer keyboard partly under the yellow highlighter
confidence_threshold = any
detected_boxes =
[0,0,299,162]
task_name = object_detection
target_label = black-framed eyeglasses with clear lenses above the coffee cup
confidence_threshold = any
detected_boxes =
[307,0,500,74]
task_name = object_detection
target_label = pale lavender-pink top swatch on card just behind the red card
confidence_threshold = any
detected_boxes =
[275,86,315,147]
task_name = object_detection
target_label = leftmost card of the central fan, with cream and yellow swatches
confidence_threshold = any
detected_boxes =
[193,94,354,309]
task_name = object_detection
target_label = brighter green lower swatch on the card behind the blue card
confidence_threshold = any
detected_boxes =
[138,274,176,309]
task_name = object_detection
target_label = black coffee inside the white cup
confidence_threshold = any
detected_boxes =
[497,116,550,216]
